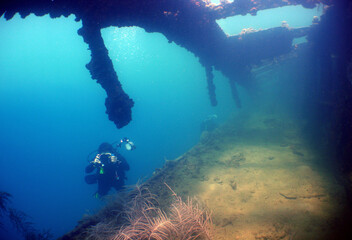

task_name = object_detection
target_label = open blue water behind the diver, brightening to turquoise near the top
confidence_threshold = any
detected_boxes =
[0,5,322,238]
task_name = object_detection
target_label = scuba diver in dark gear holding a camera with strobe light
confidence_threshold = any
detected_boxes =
[85,138,135,198]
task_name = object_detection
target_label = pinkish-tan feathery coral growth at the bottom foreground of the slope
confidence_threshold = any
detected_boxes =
[89,186,212,240]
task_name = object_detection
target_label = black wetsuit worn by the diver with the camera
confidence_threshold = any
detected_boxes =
[85,152,130,197]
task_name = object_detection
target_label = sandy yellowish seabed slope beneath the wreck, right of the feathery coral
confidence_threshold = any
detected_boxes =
[150,114,346,240]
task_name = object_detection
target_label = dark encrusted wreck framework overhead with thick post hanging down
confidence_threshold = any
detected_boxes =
[0,0,332,128]
